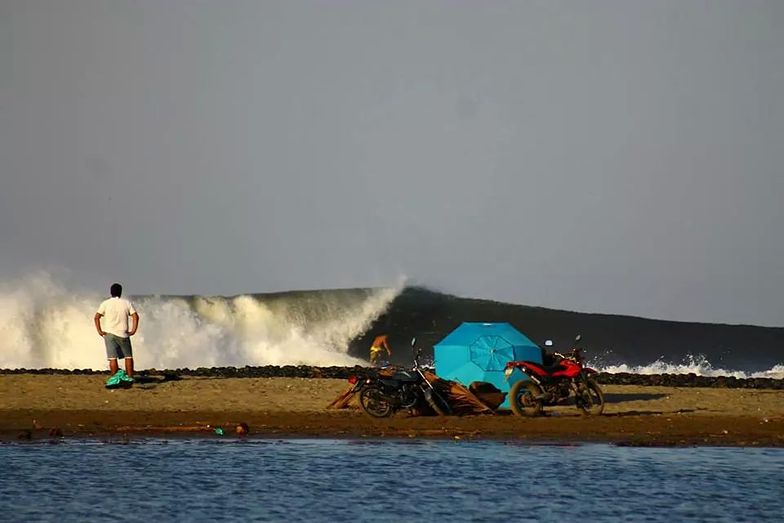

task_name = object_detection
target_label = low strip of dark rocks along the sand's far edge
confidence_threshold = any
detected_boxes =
[0,365,784,390]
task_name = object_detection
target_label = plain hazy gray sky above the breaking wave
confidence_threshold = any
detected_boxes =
[0,0,784,326]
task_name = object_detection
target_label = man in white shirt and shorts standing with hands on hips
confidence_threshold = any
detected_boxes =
[95,283,139,378]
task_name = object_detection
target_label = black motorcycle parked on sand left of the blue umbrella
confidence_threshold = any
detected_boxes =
[349,338,451,418]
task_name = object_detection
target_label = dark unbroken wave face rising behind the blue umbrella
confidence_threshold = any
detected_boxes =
[358,287,784,379]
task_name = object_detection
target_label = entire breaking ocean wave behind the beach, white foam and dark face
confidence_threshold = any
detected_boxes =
[0,273,784,379]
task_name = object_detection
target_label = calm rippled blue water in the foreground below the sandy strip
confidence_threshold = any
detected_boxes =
[0,439,784,522]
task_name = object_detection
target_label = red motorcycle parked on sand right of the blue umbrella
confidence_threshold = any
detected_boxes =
[504,335,604,416]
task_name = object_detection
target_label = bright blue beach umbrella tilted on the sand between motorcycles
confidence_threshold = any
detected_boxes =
[433,322,542,406]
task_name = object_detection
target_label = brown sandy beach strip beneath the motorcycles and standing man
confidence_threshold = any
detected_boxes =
[0,374,784,447]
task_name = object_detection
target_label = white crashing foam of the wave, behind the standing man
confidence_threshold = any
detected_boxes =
[0,274,400,370]
